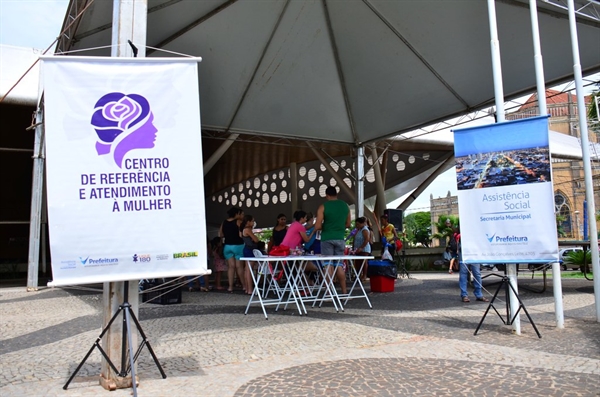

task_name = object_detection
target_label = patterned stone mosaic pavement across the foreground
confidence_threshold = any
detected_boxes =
[0,274,600,397]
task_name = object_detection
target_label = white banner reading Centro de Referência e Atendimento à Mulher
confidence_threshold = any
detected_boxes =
[42,57,207,285]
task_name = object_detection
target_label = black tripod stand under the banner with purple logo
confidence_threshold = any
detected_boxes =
[63,281,167,396]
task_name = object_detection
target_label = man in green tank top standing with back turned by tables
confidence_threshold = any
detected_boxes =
[315,186,352,294]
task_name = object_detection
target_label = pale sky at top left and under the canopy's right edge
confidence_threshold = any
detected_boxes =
[0,0,596,217]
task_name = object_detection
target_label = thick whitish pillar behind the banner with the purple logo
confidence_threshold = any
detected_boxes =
[100,0,148,392]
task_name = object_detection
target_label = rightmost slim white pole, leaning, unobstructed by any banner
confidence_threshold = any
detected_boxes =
[568,0,600,322]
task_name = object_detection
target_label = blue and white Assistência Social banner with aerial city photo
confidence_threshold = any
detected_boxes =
[454,116,558,263]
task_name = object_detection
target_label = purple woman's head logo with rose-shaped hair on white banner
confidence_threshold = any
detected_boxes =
[91,92,158,167]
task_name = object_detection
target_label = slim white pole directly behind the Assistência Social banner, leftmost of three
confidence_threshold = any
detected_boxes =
[488,0,521,335]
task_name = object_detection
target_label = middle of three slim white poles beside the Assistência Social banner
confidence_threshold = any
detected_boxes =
[529,0,565,328]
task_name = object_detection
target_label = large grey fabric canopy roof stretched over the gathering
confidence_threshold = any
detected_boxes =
[56,0,600,145]
